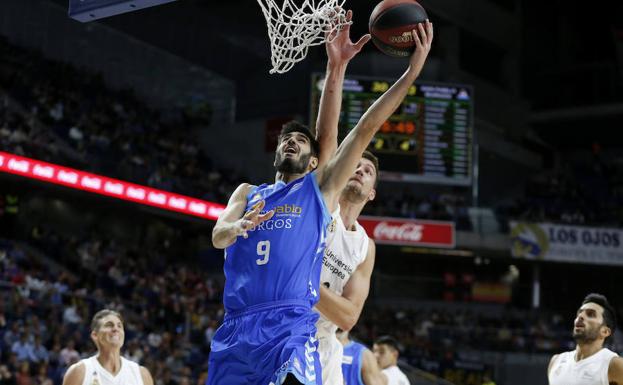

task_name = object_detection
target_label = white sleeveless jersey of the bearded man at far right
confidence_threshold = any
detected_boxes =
[548,348,618,385]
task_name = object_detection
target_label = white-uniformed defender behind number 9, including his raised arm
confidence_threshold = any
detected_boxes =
[316,11,432,385]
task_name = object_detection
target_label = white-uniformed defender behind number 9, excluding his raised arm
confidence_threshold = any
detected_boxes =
[316,152,378,385]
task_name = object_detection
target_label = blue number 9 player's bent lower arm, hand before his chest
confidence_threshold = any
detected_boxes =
[212,183,274,249]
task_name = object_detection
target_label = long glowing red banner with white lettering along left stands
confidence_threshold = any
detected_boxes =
[0,151,224,220]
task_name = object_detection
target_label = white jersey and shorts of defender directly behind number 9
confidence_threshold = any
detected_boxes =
[316,207,370,385]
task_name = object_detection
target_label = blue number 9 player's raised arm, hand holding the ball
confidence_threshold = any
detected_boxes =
[318,20,433,210]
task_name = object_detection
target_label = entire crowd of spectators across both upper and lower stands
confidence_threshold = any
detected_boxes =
[0,30,623,385]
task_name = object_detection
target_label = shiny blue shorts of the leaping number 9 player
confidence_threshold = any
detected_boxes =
[206,301,322,385]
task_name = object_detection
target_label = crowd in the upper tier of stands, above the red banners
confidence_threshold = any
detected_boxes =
[6,31,623,231]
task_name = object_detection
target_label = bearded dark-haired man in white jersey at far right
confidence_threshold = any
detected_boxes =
[547,294,623,385]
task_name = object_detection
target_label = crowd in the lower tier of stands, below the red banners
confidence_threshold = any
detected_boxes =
[0,225,623,385]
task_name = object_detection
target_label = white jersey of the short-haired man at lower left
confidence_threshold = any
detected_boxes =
[81,356,143,385]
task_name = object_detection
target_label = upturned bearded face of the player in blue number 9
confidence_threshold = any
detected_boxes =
[275,132,312,174]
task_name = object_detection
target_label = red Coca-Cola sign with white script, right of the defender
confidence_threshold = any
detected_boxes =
[358,216,455,248]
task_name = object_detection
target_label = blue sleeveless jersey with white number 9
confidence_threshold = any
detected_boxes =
[223,173,331,312]
